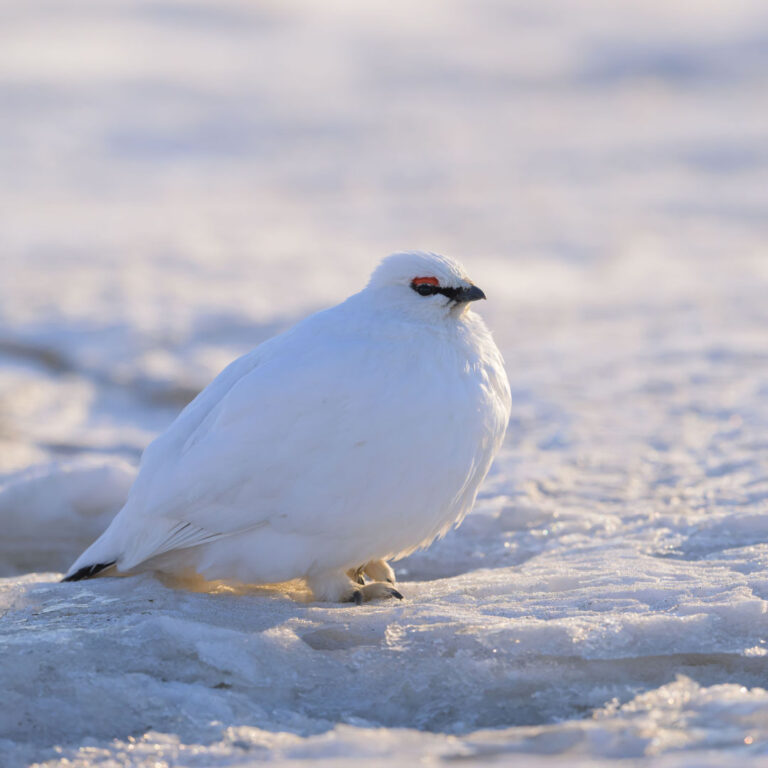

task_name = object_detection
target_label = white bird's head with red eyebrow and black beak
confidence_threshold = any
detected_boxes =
[366,251,485,322]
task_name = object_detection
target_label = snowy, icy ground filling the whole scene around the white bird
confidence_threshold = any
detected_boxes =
[0,0,768,768]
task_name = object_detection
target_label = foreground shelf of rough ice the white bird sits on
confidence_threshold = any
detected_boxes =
[0,557,768,765]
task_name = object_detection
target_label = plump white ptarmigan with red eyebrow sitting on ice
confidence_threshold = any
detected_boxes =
[64,252,510,604]
